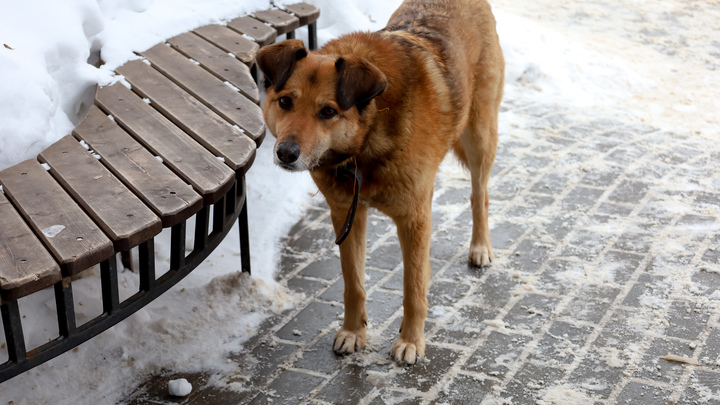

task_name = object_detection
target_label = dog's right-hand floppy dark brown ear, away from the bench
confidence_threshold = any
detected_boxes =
[335,55,388,114]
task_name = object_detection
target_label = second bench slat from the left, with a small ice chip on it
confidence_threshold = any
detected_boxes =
[0,160,113,276]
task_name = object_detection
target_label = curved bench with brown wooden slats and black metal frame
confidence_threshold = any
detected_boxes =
[0,3,320,382]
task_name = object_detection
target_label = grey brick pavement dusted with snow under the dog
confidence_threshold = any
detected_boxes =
[124,92,720,405]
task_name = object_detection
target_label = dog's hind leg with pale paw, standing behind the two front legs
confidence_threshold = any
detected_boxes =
[454,85,499,266]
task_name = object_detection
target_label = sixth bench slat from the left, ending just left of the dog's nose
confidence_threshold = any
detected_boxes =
[117,60,255,174]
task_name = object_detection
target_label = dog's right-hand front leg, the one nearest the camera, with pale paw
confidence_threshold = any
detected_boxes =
[390,201,432,364]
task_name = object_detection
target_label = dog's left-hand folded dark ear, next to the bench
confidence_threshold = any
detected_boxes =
[256,39,307,91]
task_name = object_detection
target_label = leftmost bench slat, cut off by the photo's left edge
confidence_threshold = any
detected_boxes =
[0,193,62,300]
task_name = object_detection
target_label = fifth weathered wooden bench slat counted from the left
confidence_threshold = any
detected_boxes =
[95,82,233,204]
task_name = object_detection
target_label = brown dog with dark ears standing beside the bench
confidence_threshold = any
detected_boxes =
[257,0,504,364]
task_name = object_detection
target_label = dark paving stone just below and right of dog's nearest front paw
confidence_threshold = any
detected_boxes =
[393,345,459,392]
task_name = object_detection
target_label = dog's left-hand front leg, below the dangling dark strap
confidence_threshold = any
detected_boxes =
[328,200,368,354]
